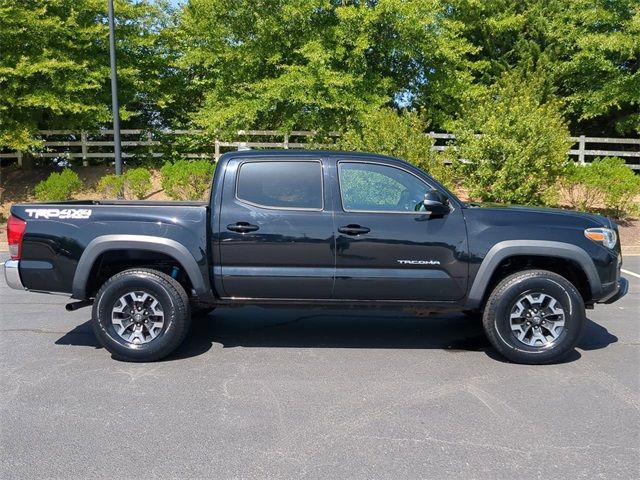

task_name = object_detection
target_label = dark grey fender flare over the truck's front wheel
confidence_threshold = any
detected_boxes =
[467,240,602,308]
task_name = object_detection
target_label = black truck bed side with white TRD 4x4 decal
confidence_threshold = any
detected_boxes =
[11,200,211,299]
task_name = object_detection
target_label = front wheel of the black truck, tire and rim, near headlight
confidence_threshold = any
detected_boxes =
[482,270,586,365]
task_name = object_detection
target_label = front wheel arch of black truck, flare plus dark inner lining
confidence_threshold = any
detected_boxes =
[467,240,602,308]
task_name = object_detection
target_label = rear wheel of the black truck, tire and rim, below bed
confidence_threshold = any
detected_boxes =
[92,268,191,362]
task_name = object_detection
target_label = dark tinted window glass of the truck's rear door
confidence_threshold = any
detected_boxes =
[236,162,322,210]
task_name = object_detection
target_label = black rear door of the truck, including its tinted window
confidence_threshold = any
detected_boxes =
[214,155,335,299]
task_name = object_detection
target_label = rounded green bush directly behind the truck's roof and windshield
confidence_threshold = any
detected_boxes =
[335,108,453,186]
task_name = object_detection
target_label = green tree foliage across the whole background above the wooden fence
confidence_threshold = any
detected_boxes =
[0,0,640,154]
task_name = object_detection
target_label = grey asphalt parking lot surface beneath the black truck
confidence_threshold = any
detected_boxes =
[0,257,640,479]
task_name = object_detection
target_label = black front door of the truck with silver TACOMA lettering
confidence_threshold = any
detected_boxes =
[334,160,468,302]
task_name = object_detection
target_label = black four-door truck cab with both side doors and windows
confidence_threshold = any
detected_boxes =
[211,153,468,302]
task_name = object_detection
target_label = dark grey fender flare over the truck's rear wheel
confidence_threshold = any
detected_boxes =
[72,235,210,300]
